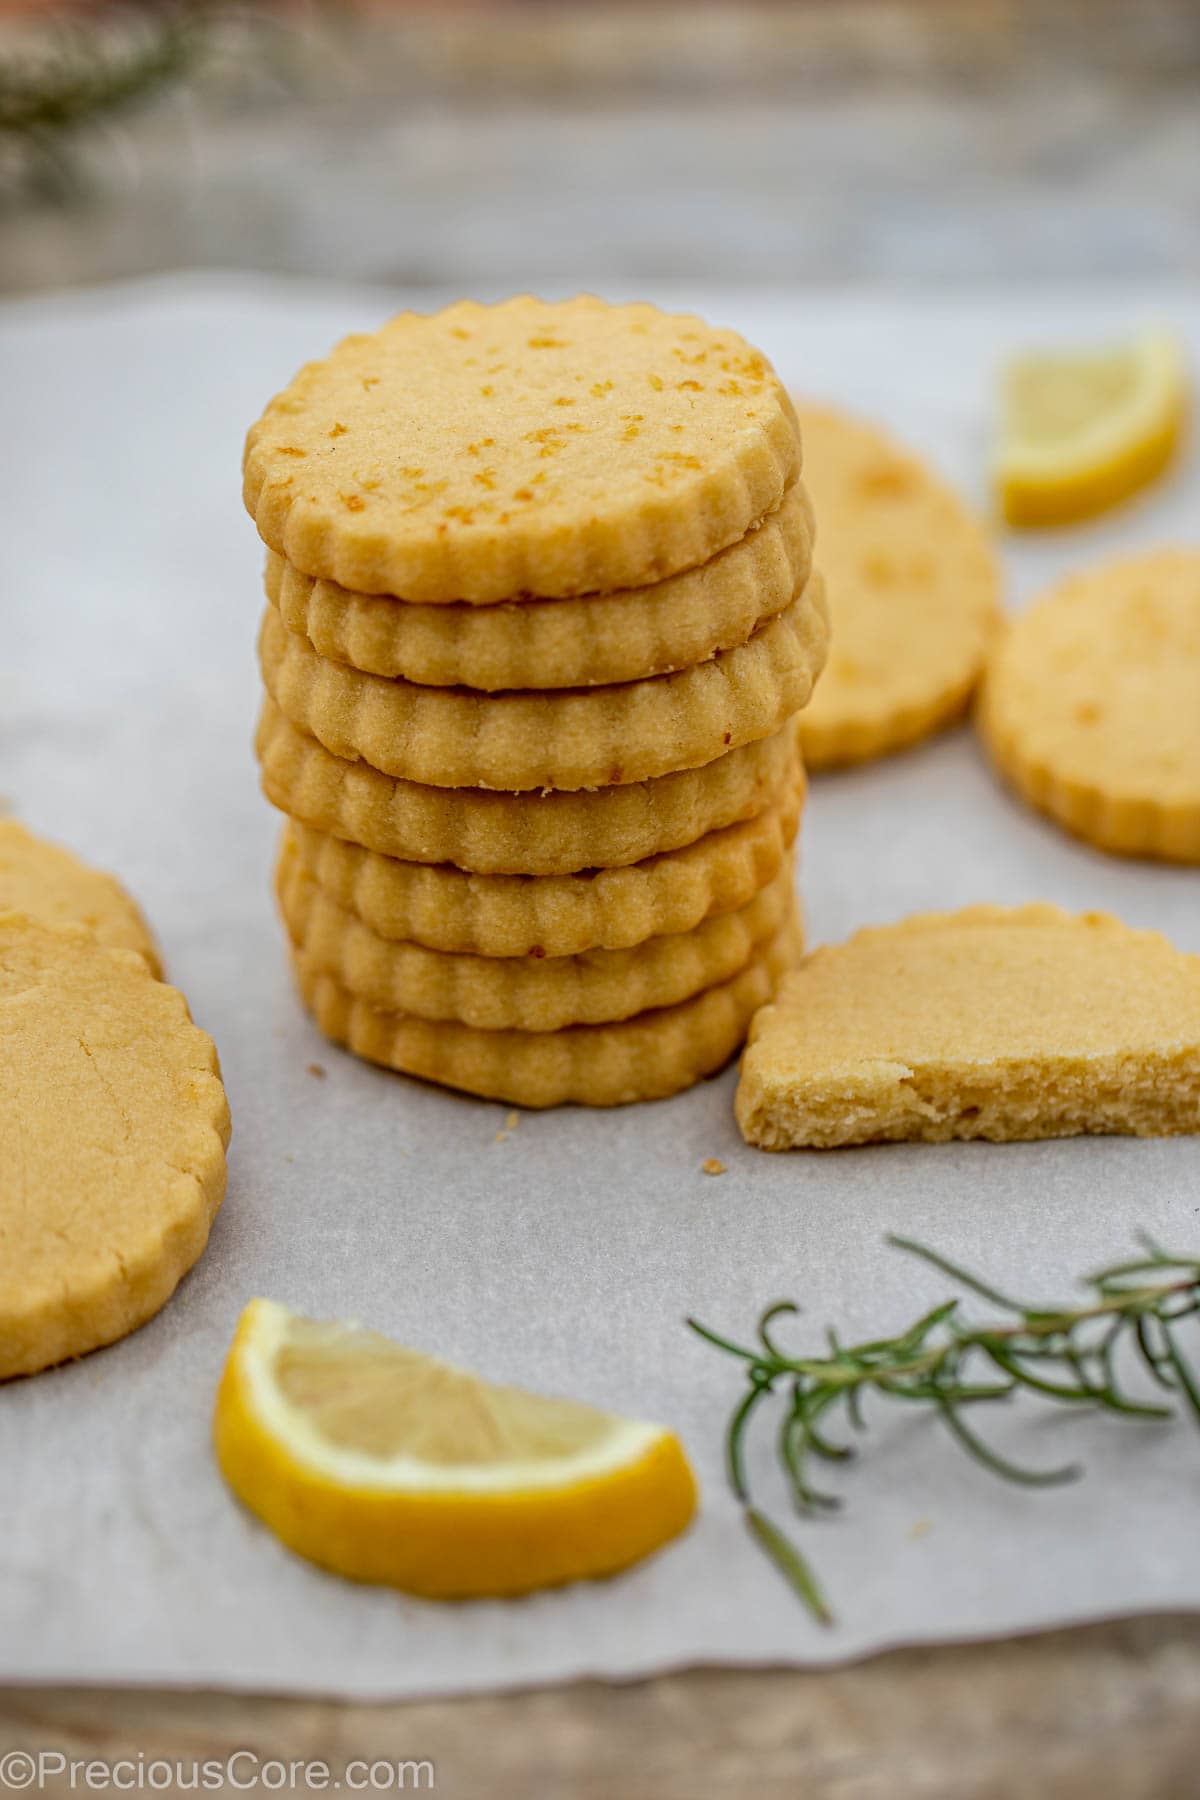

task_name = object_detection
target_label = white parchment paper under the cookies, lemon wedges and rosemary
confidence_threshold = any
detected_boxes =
[0,279,1200,1696]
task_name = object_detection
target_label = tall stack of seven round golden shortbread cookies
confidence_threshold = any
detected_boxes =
[245,297,828,1107]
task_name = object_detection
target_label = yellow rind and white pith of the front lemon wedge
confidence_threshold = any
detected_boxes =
[214,1300,696,1598]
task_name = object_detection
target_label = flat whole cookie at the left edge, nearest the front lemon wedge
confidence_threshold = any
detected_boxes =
[0,913,228,1377]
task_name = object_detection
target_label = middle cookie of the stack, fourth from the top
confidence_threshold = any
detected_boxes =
[255,697,795,875]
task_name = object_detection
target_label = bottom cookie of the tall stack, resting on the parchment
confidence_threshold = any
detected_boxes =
[293,918,802,1107]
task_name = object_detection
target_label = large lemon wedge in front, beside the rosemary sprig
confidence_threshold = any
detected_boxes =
[214,1300,696,1598]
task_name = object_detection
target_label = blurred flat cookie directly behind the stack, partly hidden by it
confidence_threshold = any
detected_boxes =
[799,403,1000,769]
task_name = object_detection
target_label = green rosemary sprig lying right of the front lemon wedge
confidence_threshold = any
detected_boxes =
[687,1233,1200,1625]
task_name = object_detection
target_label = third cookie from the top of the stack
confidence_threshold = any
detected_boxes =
[259,574,829,794]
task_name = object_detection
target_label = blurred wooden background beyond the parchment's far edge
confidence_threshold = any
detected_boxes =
[0,0,1200,295]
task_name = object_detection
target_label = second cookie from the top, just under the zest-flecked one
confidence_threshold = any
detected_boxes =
[266,482,813,691]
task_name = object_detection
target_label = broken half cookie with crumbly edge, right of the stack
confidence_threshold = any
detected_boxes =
[736,905,1200,1150]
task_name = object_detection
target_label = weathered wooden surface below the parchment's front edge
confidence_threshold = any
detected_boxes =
[0,1620,1200,1800]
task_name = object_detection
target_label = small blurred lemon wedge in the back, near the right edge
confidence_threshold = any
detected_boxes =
[995,331,1187,526]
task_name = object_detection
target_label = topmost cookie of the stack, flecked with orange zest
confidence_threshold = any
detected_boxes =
[243,295,801,605]
